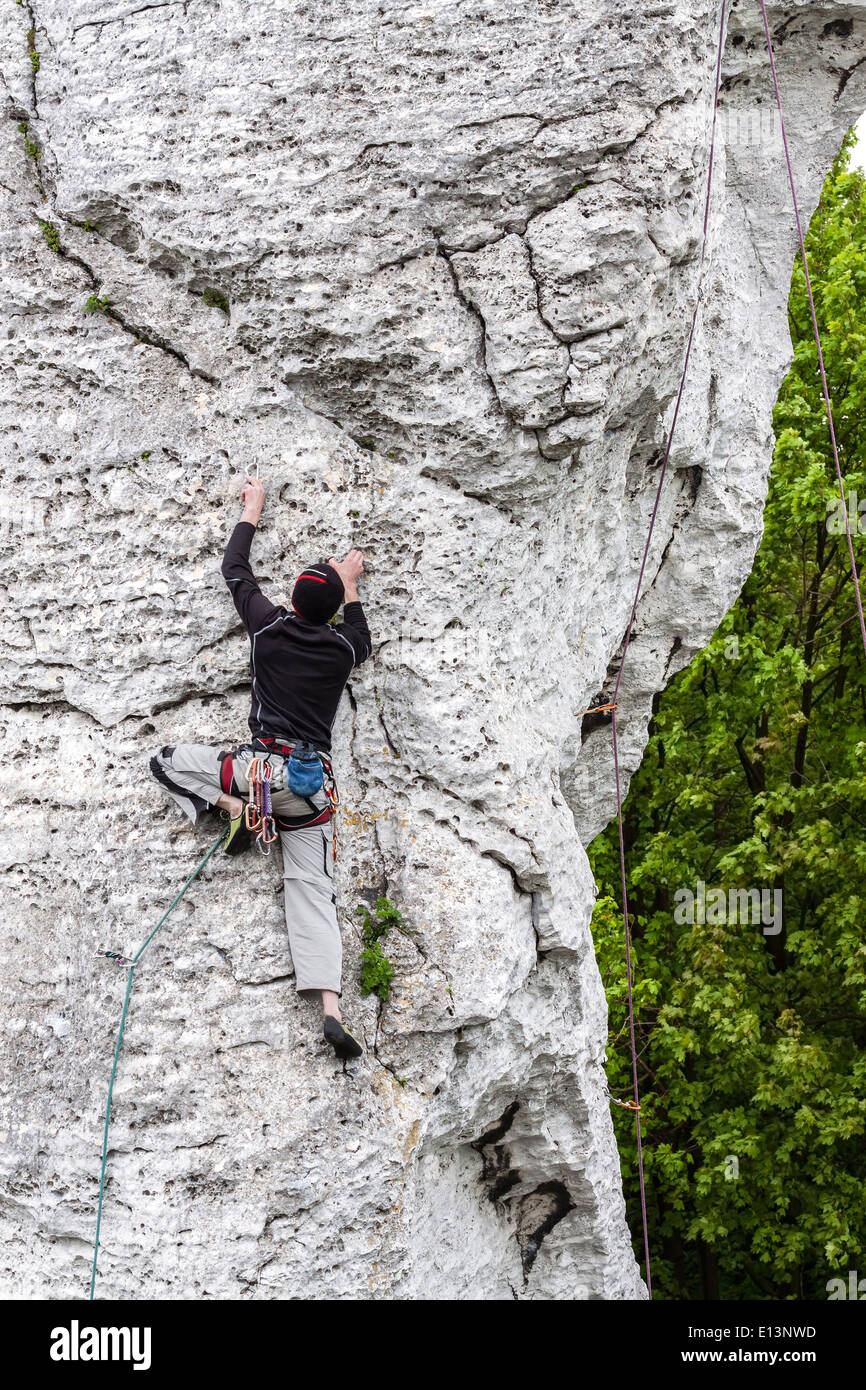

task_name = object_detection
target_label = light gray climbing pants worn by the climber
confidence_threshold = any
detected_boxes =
[150,744,342,994]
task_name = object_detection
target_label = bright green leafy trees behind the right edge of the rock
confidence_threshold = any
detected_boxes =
[591,130,866,1300]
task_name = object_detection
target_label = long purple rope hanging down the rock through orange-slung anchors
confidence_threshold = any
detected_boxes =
[612,0,727,1298]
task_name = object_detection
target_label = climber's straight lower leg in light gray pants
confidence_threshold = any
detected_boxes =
[279,803,342,1000]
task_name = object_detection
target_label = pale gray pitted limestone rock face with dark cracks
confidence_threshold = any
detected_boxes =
[0,0,866,1300]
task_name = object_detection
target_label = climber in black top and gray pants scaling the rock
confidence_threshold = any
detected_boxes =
[150,478,371,1059]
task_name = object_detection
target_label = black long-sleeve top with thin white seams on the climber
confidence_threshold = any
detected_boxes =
[222,521,373,752]
